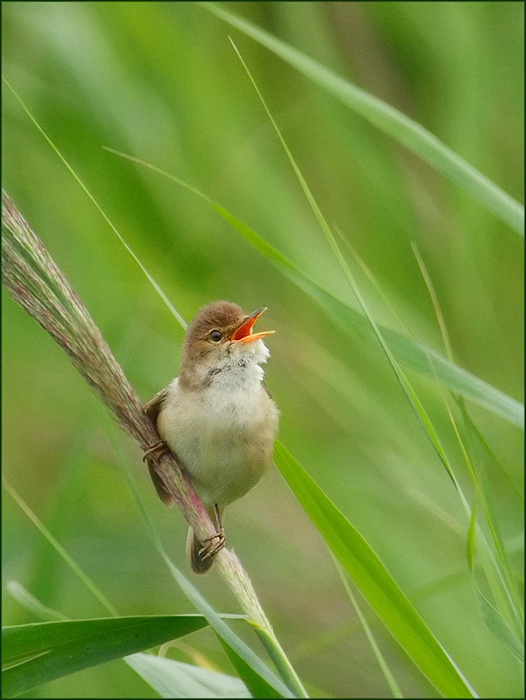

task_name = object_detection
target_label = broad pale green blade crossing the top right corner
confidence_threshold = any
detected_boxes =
[199,2,524,235]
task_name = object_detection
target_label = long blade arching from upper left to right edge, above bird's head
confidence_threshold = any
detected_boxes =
[106,148,524,427]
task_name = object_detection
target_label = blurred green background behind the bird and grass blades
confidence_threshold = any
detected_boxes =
[2,2,524,697]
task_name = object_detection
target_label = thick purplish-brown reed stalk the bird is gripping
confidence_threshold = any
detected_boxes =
[2,190,306,697]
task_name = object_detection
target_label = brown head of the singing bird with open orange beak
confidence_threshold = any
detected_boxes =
[179,301,274,388]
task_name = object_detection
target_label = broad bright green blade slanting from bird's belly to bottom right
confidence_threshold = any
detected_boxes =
[274,442,476,698]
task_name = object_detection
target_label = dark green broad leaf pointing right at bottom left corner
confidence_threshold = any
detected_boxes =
[2,615,208,697]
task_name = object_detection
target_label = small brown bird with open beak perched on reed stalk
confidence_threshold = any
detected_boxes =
[144,301,279,574]
